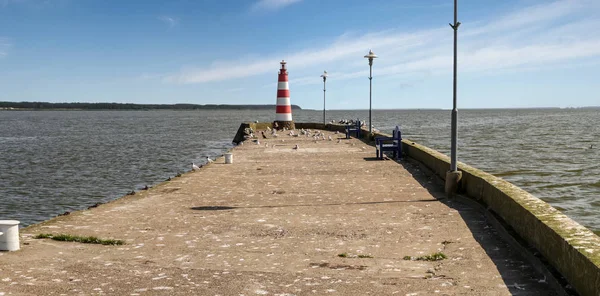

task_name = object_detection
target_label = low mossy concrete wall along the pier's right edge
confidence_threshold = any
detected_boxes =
[402,140,600,296]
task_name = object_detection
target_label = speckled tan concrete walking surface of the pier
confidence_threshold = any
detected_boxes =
[0,132,554,295]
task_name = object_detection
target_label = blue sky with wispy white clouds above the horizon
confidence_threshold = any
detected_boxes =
[0,0,600,109]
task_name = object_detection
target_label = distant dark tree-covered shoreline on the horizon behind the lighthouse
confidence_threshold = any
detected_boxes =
[0,102,302,110]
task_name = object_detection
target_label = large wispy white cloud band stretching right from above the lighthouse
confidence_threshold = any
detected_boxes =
[163,0,600,85]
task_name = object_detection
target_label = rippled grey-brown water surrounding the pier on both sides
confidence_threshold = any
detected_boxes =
[0,109,600,233]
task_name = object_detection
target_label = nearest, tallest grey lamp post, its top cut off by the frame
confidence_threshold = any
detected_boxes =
[445,0,462,196]
